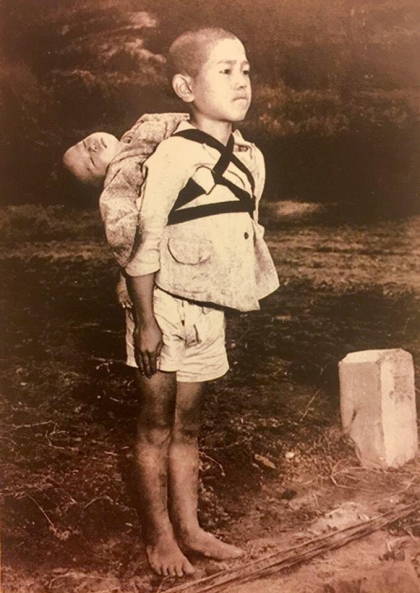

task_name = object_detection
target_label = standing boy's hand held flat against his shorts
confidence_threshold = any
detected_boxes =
[134,320,162,379]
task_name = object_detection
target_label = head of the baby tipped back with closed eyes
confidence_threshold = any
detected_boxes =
[63,132,121,187]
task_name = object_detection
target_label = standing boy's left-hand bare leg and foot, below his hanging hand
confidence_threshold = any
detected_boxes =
[136,372,194,576]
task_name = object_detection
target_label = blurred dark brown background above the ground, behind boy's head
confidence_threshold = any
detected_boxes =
[0,0,420,217]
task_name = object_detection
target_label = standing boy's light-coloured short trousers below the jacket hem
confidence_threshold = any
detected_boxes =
[126,287,229,383]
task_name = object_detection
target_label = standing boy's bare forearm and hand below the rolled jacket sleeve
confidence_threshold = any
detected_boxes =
[127,274,162,379]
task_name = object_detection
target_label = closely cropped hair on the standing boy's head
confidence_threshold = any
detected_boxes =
[167,27,238,80]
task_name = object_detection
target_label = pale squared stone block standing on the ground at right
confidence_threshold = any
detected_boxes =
[339,348,418,468]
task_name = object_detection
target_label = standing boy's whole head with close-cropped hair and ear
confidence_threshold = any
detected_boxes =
[168,28,251,123]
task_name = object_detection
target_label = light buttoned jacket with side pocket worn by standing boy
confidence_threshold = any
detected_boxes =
[125,122,279,311]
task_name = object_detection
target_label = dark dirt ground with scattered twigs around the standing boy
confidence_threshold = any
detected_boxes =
[0,206,420,593]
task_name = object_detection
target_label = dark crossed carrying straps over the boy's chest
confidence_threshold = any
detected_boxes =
[168,129,255,225]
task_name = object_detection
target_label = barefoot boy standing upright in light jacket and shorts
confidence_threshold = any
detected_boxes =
[113,29,278,576]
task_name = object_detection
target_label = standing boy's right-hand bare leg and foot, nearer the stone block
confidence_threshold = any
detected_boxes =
[169,382,243,560]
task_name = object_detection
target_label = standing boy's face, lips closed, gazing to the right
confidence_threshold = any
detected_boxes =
[191,39,251,123]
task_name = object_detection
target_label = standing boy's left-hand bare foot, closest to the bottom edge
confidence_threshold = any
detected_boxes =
[146,535,195,577]
